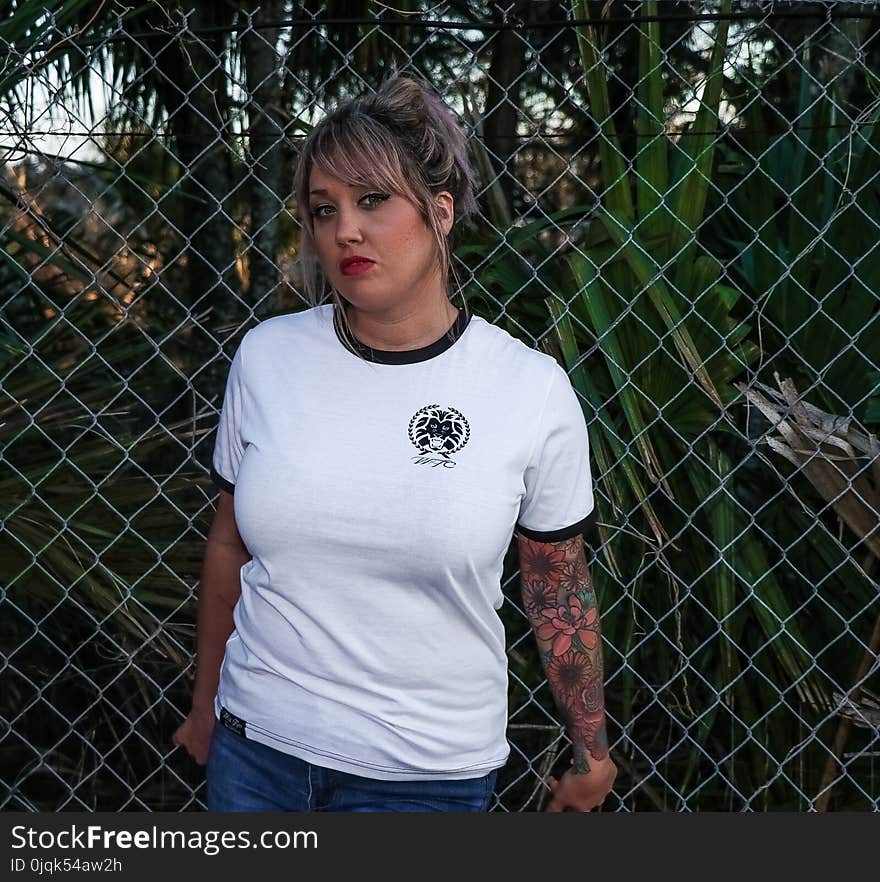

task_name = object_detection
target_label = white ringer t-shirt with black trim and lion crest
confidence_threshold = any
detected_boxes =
[211,303,594,780]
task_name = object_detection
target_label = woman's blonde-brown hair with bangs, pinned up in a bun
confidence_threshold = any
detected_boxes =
[293,69,477,356]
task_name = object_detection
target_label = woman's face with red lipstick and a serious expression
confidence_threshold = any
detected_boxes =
[309,168,452,310]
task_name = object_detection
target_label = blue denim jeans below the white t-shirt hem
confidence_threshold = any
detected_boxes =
[205,721,498,812]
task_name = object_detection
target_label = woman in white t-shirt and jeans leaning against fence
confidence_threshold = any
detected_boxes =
[168,70,616,811]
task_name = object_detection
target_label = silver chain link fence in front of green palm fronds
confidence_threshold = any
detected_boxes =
[0,0,880,811]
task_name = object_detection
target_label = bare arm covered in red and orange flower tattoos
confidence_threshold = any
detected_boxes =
[517,534,617,811]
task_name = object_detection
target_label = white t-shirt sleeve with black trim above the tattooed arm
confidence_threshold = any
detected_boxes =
[516,362,595,542]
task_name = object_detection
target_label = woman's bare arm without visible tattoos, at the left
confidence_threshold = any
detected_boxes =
[172,490,251,765]
